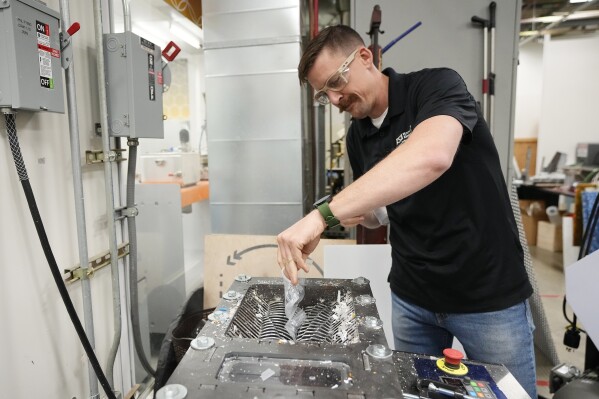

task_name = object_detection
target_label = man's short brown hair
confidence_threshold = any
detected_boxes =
[297,25,364,84]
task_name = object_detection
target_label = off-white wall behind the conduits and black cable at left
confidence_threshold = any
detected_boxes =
[0,0,128,398]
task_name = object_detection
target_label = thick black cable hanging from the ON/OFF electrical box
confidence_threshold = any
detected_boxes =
[3,111,116,399]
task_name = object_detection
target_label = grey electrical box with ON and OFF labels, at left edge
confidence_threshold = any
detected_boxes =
[0,0,64,113]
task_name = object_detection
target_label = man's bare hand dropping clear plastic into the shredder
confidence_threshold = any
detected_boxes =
[277,210,327,285]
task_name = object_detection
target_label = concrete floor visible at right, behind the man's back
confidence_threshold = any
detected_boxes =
[529,246,586,399]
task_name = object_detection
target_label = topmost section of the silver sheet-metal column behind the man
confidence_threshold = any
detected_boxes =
[202,0,300,47]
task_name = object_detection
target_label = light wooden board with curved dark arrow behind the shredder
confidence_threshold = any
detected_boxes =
[204,234,356,309]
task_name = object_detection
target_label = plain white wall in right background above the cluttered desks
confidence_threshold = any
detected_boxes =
[515,33,599,173]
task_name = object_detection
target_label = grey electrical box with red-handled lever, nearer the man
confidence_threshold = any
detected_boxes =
[104,32,164,138]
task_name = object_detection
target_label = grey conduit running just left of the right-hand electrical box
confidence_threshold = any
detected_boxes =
[94,0,122,385]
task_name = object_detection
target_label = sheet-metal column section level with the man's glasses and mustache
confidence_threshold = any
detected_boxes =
[206,74,301,143]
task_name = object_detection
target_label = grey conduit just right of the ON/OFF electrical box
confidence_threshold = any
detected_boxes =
[60,0,99,399]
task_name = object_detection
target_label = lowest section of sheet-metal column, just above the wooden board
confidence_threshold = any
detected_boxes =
[210,204,302,235]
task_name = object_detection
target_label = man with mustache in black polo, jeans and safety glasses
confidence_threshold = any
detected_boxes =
[277,25,537,398]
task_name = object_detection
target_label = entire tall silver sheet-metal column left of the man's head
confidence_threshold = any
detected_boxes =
[203,0,303,234]
